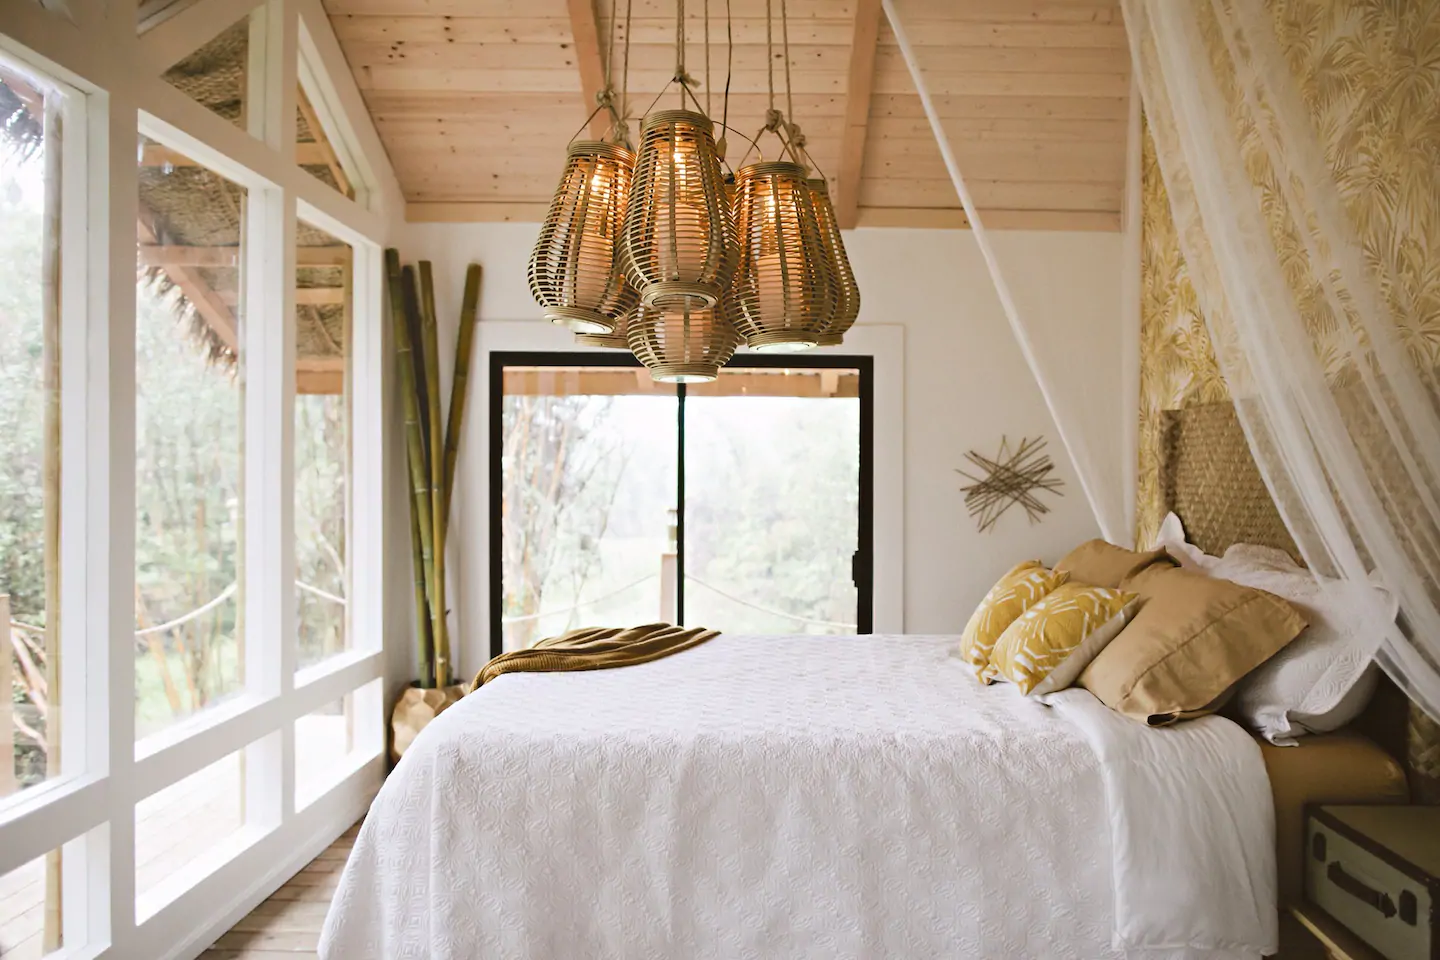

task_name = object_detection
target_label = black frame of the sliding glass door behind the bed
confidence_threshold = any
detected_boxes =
[487,350,876,656]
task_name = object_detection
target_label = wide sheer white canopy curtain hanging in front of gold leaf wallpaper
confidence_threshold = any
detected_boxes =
[1122,0,1440,718]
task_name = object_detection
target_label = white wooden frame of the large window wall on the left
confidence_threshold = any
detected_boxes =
[0,0,403,960]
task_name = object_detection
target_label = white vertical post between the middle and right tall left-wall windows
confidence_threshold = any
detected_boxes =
[242,0,298,826]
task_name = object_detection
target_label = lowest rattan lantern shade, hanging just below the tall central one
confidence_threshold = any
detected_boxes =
[626,301,740,383]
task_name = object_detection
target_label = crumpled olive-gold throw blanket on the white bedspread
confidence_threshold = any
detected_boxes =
[471,623,720,689]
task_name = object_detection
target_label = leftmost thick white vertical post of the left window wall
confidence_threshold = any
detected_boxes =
[100,91,140,956]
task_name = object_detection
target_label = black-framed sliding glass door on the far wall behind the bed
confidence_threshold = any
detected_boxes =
[490,353,871,653]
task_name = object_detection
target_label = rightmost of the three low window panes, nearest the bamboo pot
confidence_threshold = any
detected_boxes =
[295,679,383,809]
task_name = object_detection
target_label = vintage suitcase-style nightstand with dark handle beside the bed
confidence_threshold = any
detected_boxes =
[1295,806,1440,960]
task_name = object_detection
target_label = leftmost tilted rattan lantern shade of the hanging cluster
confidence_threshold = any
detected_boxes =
[530,141,635,334]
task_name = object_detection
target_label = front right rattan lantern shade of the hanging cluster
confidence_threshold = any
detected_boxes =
[730,161,835,353]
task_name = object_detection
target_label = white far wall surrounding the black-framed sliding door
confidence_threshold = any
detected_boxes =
[402,223,1132,671]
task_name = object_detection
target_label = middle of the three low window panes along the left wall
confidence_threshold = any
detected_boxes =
[135,734,247,923]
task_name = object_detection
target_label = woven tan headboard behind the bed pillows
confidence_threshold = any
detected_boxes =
[1159,403,1440,802]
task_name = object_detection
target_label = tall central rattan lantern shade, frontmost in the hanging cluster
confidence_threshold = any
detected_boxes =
[624,109,734,307]
